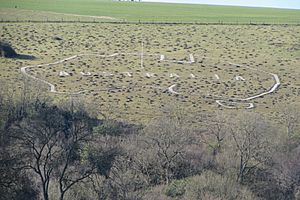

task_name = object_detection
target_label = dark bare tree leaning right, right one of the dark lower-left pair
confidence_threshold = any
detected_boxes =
[56,109,96,200]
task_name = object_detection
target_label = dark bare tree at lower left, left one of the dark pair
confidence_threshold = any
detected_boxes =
[13,105,62,200]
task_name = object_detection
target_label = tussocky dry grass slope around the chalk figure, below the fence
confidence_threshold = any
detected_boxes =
[0,23,300,121]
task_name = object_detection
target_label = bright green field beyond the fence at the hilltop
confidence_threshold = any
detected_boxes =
[0,0,300,24]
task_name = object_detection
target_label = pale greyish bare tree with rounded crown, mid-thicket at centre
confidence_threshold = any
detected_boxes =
[143,118,193,184]
